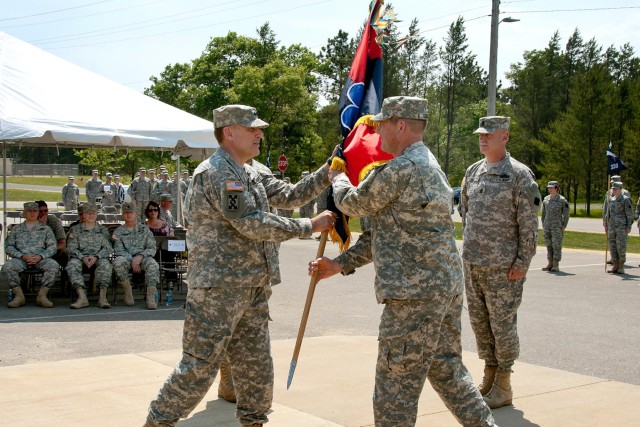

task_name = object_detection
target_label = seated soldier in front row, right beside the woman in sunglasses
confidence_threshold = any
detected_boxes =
[113,202,160,310]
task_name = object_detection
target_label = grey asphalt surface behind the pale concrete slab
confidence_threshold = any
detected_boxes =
[0,239,640,385]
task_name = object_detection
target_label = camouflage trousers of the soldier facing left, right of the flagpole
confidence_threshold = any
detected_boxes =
[373,294,495,427]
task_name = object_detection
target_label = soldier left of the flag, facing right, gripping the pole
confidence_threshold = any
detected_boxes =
[145,105,335,427]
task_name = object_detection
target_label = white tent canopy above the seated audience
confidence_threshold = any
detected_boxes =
[0,32,218,158]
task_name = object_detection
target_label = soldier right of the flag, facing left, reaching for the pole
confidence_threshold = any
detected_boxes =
[309,96,495,426]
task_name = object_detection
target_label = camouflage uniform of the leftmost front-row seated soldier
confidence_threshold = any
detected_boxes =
[2,222,60,288]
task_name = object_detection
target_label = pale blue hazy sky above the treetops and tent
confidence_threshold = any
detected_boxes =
[0,0,640,96]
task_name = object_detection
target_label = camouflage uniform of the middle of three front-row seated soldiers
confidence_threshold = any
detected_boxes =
[65,224,113,289]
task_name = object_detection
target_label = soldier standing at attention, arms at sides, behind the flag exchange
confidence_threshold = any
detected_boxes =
[460,116,541,409]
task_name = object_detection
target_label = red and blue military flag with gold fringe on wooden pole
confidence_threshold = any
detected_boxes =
[327,0,395,252]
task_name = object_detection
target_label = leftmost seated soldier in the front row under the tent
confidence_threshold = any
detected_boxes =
[2,202,60,308]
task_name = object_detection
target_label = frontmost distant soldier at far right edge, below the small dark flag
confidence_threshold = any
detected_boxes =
[605,181,633,274]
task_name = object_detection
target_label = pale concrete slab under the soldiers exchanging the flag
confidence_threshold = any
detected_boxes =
[0,336,640,427]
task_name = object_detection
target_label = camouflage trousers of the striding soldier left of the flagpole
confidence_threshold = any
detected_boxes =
[147,286,273,426]
